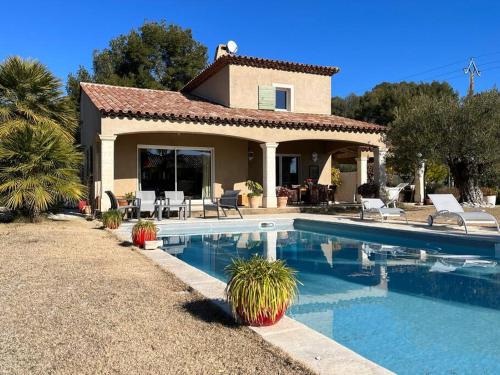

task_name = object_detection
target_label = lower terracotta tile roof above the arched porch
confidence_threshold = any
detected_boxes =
[80,82,384,133]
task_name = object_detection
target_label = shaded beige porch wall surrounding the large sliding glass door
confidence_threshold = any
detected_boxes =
[114,133,248,196]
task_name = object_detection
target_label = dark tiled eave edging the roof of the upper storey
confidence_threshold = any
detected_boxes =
[181,55,340,92]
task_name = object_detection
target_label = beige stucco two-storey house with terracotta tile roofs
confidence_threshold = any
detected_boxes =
[80,46,386,210]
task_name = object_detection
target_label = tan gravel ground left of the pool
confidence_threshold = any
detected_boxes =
[0,220,311,374]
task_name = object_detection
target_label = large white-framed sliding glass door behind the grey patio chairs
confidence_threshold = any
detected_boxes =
[138,146,212,199]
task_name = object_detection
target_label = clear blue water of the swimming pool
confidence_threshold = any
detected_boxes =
[159,225,500,374]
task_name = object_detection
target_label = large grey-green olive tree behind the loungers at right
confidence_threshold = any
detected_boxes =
[386,89,500,204]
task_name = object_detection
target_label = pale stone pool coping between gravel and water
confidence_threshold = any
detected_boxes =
[110,225,394,375]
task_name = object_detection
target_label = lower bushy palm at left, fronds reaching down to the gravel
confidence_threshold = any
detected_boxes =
[0,124,85,221]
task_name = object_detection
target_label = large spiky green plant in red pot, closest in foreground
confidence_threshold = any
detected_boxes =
[226,255,298,327]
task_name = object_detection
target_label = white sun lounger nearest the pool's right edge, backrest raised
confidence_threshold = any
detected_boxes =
[427,194,500,233]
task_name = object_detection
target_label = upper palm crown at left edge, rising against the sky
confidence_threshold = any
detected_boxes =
[0,56,77,140]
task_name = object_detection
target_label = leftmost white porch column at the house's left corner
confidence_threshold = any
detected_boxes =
[99,135,116,212]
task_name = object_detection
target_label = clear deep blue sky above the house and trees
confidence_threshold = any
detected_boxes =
[0,0,500,96]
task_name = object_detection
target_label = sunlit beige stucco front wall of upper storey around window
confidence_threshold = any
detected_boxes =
[229,65,331,114]
